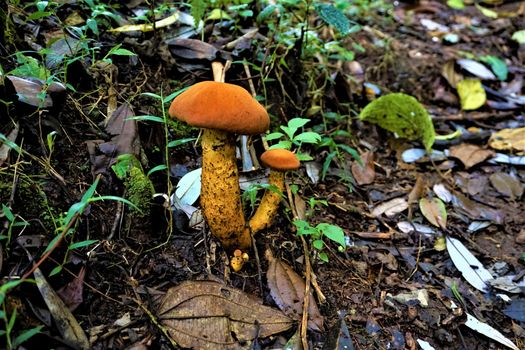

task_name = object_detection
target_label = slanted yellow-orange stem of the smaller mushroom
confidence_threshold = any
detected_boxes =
[249,170,284,234]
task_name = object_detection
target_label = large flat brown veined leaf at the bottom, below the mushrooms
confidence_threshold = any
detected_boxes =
[158,281,292,350]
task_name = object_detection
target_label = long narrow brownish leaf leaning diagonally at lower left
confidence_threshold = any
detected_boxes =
[33,268,91,350]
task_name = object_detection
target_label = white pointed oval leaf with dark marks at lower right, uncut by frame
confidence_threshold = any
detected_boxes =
[446,237,492,292]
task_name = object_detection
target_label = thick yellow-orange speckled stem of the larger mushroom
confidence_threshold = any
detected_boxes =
[201,129,251,250]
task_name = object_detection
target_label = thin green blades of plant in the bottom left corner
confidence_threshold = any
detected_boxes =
[0,279,44,350]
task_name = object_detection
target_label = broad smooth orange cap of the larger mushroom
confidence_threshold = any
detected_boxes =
[169,81,270,135]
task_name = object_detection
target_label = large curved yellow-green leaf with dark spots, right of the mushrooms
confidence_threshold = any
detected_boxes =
[359,93,436,151]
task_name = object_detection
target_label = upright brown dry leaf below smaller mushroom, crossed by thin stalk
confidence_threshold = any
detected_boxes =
[265,250,324,332]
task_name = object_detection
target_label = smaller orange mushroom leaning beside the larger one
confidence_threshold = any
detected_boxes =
[249,148,300,234]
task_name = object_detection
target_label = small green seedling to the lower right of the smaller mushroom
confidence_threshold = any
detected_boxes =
[293,220,346,262]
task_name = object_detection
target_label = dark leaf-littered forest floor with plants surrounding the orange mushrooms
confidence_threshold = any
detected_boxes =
[0,0,525,349]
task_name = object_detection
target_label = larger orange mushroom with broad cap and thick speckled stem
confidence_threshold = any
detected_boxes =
[169,81,270,251]
